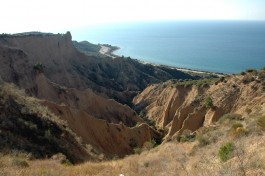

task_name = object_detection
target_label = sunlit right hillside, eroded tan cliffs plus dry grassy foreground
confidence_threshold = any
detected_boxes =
[0,70,265,176]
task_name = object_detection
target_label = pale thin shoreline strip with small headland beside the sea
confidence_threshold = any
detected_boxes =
[99,44,226,77]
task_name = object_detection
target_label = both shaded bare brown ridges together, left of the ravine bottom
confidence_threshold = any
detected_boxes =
[36,74,159,157]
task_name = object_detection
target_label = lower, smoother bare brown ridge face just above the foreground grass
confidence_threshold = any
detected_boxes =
[44,102,157,157]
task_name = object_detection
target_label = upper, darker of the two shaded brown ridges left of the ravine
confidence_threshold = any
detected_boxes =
[36,73,143,126]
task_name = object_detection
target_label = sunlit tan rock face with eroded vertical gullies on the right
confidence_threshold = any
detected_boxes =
[134,71,265,138]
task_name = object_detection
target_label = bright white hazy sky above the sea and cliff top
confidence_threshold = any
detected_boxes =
[0,0,265,33]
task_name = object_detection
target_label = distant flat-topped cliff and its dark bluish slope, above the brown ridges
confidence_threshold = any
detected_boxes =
[0,32,191,103]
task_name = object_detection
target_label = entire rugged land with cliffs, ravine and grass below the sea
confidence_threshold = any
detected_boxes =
[0,32,265,176]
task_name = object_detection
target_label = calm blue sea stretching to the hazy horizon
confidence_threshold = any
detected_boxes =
[71,21,265,73]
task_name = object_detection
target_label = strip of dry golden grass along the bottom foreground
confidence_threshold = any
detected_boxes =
[0,130,265,176]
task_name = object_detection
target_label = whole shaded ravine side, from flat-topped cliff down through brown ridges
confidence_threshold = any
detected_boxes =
[0,33,180,156]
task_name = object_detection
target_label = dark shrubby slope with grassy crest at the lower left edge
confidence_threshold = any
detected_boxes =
[0,83,93,163]
